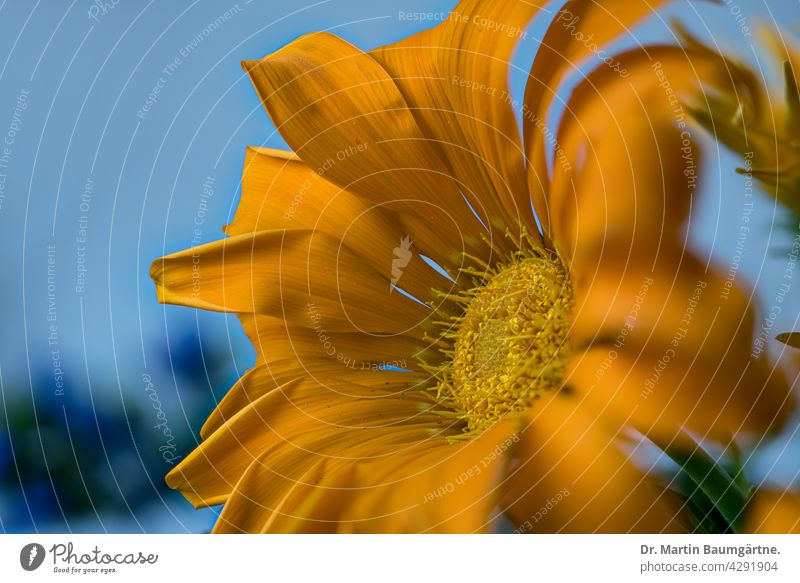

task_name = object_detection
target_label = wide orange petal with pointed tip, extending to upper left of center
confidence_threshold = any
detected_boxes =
[243,33,488,267]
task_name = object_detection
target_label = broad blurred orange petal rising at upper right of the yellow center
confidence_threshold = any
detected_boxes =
[547,47,720,266]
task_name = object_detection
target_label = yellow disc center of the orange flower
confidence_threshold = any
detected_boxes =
[436,250,572,433]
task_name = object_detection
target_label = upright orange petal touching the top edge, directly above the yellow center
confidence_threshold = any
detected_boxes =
[370,0,539,245]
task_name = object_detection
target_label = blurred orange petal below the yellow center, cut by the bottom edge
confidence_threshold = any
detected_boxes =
[505,392,684,533]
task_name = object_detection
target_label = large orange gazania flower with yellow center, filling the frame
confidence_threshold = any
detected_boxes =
[152,0,788,532]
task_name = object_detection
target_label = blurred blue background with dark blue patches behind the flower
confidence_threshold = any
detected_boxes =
[0,0,800,532]
